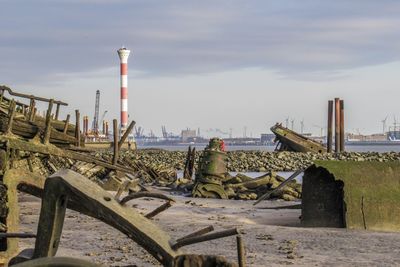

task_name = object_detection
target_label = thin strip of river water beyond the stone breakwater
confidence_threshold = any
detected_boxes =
[138,144,400,153]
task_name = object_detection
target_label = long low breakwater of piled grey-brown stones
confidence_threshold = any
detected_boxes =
[126,149,400,172]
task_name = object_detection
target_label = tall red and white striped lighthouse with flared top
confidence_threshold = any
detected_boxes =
[118,47,131,132]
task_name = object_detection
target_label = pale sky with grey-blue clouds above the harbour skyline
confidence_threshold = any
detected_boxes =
[0,0,400,137]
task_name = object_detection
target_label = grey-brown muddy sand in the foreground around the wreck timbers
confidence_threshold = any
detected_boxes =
[20,192,400,266]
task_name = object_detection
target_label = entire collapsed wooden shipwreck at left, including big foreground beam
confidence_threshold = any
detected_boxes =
[0,86,245,267]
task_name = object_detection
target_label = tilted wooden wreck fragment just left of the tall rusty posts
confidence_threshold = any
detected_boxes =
[271,123,327,153]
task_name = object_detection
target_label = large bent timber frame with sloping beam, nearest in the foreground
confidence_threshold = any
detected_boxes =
[0,170,244,267]
